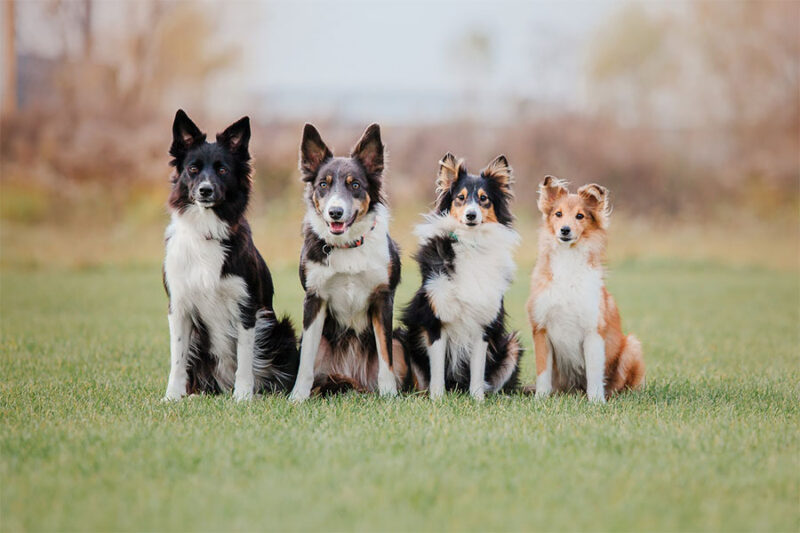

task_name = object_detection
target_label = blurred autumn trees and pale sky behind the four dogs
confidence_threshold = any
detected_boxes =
[0,0,800,268]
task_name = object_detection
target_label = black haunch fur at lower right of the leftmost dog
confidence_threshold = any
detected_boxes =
[253,309,300,392]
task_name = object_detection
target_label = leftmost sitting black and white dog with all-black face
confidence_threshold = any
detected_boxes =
[164,110,298,400]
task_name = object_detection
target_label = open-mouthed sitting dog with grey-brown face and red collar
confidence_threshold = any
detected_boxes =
[290,124,407,402]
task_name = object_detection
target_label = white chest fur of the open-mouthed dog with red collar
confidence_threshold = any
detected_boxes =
[306,210,391,333]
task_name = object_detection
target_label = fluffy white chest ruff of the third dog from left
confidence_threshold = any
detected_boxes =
[417,216,519,353]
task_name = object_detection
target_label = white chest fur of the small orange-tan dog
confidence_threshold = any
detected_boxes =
[533,245,603,379]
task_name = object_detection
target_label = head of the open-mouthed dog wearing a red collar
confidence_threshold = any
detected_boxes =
[300,124,384,235]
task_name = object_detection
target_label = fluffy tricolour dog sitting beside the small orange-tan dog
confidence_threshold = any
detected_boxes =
[395,153,522,400]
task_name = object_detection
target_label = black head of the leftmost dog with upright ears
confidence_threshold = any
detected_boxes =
[169,109,252,212]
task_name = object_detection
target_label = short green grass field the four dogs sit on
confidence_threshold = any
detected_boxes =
[0,260,800,531]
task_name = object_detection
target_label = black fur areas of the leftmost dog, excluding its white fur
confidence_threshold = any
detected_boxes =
[164,110,299,393]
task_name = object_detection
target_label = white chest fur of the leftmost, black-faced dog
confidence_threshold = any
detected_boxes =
[164,206,248,370]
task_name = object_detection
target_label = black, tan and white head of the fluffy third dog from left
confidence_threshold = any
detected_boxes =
[436,152,514,227]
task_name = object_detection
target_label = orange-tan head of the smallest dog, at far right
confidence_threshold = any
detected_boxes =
[538,176,609,246]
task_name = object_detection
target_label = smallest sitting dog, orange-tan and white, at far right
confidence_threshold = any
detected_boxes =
[528,176,644,402]
